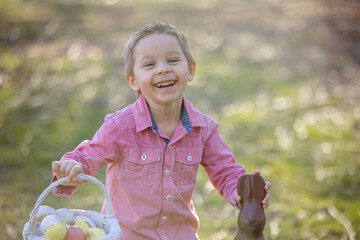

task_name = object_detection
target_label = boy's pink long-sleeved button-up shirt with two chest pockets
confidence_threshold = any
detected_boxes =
[54,96,245,240]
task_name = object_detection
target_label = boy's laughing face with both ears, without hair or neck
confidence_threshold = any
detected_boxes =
[126,33,195,108]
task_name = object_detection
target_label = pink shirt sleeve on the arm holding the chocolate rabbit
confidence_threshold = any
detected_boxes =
[201,124,246,207]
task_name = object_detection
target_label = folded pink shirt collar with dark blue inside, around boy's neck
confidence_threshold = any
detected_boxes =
[132,95,205,132]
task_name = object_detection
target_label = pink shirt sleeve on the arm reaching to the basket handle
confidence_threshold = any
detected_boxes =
[52,115,121,196]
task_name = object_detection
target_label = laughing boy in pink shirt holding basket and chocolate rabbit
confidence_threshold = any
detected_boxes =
[52,23,270,240]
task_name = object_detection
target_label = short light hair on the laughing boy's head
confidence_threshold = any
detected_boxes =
[124,22,195,76]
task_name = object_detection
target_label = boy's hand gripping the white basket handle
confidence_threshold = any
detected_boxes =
[52,160,86,186]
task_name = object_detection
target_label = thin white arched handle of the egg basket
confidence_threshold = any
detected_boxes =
[29,173,113,229]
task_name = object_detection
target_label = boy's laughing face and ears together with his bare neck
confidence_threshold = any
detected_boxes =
[126,34,195,139]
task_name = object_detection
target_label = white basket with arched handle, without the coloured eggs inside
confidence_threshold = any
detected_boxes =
[23,174,122,240]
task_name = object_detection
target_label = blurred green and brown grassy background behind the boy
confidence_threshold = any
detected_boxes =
[0,0,360,240]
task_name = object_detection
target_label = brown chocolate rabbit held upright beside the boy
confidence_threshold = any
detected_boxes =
[234,174,266,240]
